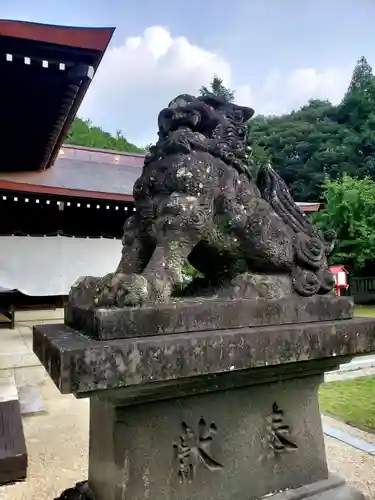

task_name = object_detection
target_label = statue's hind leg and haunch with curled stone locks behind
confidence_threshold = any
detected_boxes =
[223,184,326,298]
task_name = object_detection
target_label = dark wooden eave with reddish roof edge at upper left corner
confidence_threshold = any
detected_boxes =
[0,20,114,172]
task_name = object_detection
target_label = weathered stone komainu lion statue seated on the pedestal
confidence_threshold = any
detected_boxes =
[70,95,335,307]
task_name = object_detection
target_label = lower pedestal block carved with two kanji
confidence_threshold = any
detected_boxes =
[89,376,328,500]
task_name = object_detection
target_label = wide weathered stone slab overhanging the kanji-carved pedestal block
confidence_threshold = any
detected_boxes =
[34,318,375,394]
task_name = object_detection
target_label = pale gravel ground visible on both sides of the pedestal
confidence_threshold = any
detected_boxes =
[0,379,375,500]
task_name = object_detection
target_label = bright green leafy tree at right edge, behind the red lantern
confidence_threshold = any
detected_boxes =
[314,174,375,272]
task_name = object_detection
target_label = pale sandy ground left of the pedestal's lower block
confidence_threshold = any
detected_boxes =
[0,379,89,500]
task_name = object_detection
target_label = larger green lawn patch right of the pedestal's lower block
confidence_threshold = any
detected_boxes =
[319,377,375,430]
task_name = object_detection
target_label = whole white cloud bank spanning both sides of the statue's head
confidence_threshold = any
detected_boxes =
[80,26,350,144]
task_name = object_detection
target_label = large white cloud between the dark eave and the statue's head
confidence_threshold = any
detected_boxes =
[80,26,235,144]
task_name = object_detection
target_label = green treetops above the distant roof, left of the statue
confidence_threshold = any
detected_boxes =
[65,118,143,153]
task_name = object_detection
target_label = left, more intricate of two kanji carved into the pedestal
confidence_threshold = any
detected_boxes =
[174,418,223,481]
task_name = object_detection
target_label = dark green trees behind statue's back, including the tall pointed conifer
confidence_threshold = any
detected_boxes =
[249,57,375,201]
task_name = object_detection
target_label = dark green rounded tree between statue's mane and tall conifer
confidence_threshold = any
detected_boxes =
[249,100,352,201]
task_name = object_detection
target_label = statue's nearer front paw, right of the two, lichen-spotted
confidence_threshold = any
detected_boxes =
[95,273,149,307]
